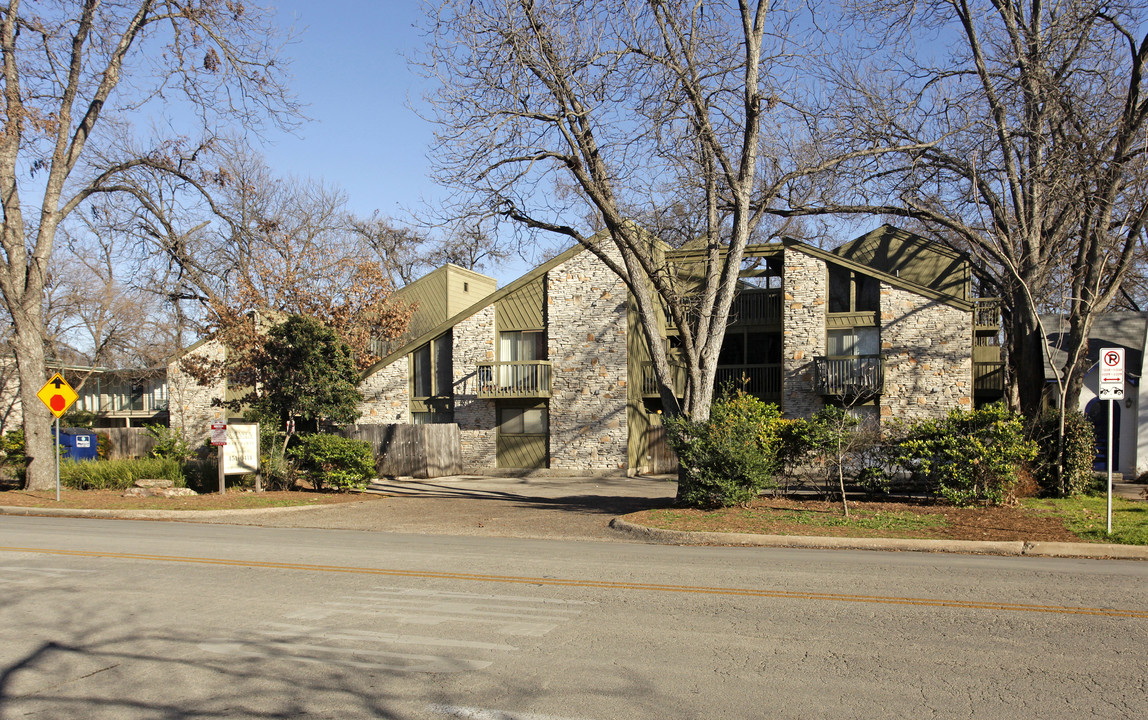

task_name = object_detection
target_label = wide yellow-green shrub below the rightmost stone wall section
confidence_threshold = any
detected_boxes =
[897,403,1037,505]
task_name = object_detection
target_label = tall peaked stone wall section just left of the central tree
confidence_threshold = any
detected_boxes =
[546,253,628,470]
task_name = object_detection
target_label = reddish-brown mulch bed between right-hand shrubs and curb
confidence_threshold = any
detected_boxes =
[623,498,1080,542]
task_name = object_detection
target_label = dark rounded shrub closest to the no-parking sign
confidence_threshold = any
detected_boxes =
[1029,410,1096,496]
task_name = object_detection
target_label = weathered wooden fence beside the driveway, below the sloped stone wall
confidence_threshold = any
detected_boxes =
[344,423,463,478]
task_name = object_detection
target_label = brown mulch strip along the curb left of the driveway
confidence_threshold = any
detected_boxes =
[0,490,379,511]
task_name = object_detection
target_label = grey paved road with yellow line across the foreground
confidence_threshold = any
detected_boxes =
[0,517,1148,720]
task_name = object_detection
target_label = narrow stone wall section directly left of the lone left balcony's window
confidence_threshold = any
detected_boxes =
[451,305,498,469]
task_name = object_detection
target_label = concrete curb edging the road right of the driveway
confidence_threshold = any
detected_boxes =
[610,518,1148,560]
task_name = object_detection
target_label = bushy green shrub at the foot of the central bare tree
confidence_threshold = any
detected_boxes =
[666,390,786,508]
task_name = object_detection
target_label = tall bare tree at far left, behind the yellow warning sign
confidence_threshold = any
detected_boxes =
[0,0,293,488]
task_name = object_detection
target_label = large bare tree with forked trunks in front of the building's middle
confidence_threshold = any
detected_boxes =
[425,0,913,427]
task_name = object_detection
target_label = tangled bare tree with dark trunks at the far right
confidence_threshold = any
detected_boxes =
[798,0,1148,427]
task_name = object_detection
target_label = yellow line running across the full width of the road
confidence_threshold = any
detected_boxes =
[0,547,1148,619]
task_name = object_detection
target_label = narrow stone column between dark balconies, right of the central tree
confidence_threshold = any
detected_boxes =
[782,248,829,417]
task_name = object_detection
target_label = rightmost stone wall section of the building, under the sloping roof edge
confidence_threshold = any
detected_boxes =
[881,282,972,420]
